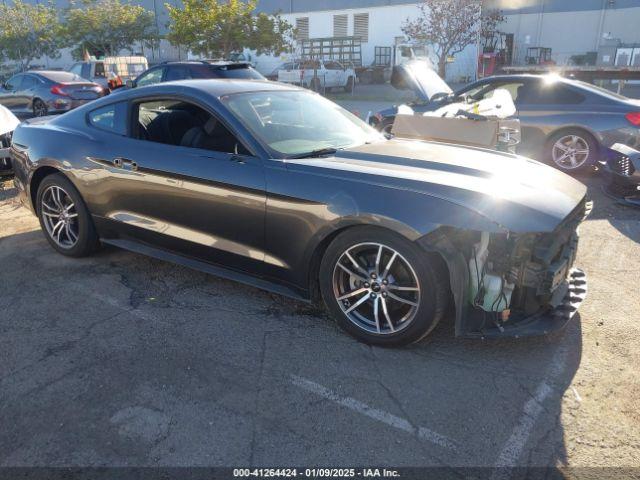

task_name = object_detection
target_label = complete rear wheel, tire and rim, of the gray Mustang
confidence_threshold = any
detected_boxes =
[36,173,99,257]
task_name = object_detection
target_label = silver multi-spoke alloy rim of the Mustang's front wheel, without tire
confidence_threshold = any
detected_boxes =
[333,243,420,335]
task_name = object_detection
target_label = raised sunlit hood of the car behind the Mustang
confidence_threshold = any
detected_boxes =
[391,60,453,102]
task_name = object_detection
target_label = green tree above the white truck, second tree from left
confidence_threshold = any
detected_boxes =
[64,0,158,57]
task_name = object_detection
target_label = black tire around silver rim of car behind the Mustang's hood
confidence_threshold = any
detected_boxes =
[544,128,600,174]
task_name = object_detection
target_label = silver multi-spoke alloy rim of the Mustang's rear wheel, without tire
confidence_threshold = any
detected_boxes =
[40,185,80,249]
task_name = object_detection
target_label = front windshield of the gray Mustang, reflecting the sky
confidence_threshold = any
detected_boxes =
[224,90,385,156]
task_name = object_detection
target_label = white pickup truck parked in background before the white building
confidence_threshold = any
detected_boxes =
[278,60,356,92]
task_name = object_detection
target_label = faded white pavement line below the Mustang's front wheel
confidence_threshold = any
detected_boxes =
[291,375,458,451]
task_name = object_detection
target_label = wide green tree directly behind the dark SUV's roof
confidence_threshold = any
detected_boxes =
[165,0,293,58]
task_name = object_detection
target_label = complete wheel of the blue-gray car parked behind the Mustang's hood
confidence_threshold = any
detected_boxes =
[546,129,599,172]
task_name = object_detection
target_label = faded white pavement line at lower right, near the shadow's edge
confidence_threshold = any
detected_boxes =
[491,346,567,480]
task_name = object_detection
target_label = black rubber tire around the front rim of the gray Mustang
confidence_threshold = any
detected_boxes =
[319,226,449,347]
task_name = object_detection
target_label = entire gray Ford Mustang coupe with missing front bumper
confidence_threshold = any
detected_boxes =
[11,80,588,345]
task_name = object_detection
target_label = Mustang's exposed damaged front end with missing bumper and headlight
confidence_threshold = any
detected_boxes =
[421,201,591,338]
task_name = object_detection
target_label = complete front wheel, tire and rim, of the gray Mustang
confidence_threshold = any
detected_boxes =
[320,227,448,346]
